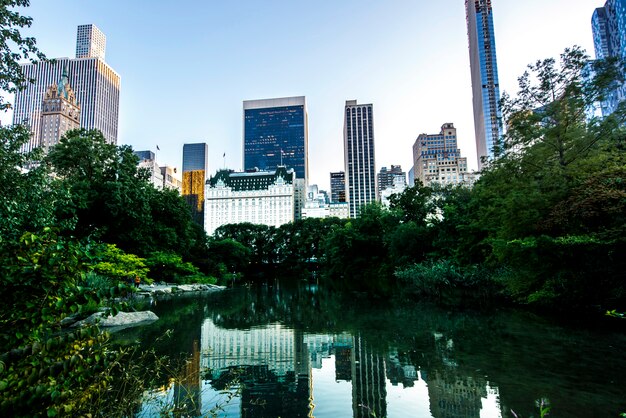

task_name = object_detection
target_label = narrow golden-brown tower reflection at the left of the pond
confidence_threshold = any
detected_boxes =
[174,340,202,417]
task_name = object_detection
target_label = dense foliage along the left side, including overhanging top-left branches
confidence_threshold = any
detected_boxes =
[0,7,211,417]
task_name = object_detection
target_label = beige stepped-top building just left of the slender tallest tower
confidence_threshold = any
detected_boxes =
[413,123,473,186]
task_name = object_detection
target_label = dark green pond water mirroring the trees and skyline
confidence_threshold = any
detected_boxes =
[118,282,626,418]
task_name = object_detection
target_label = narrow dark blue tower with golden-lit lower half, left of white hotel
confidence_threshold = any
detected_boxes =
[183,143,209,226]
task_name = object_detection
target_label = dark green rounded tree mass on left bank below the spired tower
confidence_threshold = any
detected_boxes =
[46,129,207,261]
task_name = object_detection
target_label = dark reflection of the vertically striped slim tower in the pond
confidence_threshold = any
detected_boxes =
[352,335,387,418]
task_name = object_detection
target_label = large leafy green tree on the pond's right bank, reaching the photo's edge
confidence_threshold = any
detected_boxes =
[469,48,626,308]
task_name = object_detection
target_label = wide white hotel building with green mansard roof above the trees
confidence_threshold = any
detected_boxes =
[204,166,296,235]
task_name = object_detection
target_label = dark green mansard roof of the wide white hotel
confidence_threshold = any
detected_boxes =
[207,166,294,192]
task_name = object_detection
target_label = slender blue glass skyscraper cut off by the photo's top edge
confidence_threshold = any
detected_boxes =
[465,0,502,170]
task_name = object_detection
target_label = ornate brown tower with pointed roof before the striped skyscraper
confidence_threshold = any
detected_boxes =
[38,70,80,153]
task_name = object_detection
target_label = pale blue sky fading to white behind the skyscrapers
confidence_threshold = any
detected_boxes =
[0,0,604,190]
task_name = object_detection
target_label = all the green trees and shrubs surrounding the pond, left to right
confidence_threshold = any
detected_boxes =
[0,0,626,417]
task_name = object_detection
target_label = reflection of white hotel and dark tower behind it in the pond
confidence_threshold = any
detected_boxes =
[201,320,313,418]
